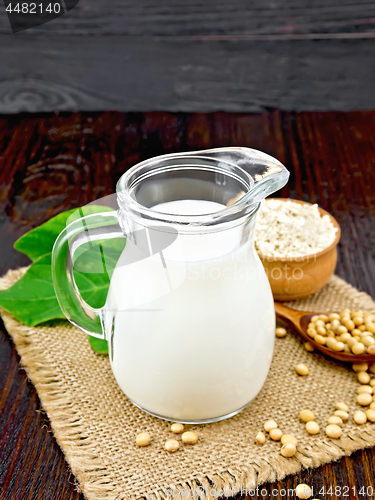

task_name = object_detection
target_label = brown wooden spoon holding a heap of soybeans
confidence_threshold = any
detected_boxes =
[275,302,375,363]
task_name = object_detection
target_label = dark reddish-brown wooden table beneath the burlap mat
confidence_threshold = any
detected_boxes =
[0,111,375,500]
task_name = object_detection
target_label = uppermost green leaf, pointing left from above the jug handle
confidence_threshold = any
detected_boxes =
[14,205,113,262]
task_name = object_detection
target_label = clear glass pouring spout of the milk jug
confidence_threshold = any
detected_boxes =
[180,147,290,205]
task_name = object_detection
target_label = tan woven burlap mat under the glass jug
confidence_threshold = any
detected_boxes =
[0,270,375,500]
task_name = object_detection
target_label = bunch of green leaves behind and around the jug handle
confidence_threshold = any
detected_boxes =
[0,205,126,354]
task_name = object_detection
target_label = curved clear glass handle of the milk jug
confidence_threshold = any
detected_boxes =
[52,211,125,340]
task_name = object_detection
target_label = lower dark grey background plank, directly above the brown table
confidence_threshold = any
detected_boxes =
[0,36,375,113]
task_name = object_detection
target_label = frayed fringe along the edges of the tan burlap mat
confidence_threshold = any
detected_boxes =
[0,269,375,500]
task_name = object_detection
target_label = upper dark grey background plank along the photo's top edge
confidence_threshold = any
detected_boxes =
[0,0,375,37]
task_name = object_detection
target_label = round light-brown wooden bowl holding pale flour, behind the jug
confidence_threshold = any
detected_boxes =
[258,198,341,302]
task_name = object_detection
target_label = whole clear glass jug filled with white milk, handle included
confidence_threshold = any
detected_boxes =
[52,147,289,423]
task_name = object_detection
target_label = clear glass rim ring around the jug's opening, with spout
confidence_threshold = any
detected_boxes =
[116,147,289,228]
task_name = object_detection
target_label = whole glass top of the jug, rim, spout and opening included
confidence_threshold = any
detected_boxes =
[117,147,289,230]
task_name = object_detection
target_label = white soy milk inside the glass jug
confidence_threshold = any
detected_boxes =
[104,200,275,421]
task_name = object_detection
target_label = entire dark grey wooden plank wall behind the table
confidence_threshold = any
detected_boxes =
[0,0,375,113]
